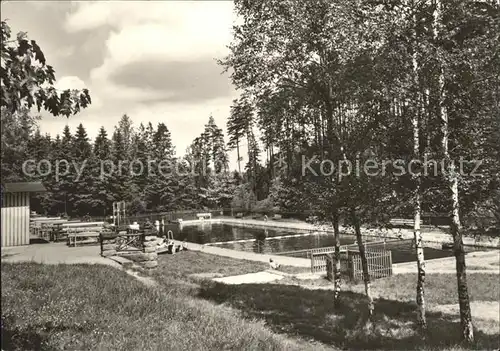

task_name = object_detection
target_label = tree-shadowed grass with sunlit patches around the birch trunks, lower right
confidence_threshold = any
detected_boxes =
[200,277,500,350]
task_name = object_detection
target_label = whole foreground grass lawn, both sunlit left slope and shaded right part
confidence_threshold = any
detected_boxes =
[2,251,500,351]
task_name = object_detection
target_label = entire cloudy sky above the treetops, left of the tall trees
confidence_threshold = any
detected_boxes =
[1,1,243,169]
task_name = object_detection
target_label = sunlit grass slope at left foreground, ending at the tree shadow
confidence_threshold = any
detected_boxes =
[1,262,334,351]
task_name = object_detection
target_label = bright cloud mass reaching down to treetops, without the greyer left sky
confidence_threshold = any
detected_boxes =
[48,1,242,169]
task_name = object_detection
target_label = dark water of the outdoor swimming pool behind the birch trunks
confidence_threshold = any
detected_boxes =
[169,222,478,263]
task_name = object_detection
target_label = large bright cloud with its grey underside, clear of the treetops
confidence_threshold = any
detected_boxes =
[65,1,233,101]
